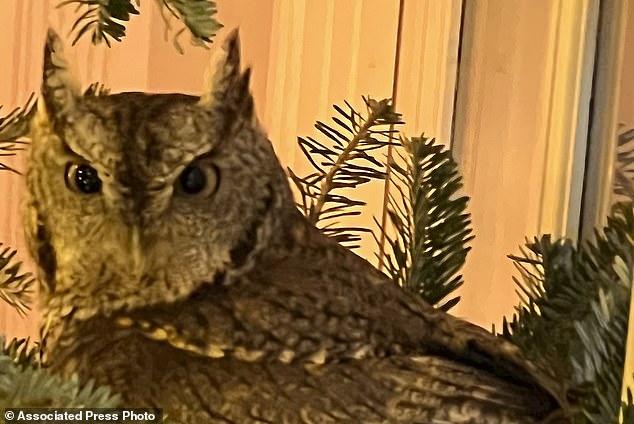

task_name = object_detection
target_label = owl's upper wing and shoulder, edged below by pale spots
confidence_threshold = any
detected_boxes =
[110,224,569,416]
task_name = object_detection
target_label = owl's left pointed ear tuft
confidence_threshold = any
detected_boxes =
[42,29,80,120]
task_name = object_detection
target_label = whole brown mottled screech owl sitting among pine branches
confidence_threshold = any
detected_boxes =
[25,31,568,424]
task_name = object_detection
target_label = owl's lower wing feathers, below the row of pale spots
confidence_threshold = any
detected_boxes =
[56,319,556,424]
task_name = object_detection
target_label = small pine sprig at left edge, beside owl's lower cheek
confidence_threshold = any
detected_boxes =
[0,243,35,315]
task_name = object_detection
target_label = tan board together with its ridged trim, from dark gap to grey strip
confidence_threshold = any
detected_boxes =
[452,0,598,327]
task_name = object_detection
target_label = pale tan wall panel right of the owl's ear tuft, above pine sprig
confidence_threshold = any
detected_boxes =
[263,0,398,173]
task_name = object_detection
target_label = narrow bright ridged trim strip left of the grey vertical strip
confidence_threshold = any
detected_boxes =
[539,0,599,239]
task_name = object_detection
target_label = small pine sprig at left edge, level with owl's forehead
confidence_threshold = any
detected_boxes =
[0,94,36,174]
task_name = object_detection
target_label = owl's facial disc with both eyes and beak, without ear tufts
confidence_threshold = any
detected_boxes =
[38,126,232,317]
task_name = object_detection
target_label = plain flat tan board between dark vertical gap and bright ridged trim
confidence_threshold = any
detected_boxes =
[454,0,553,325]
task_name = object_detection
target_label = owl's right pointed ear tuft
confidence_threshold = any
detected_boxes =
[199,29,254,117]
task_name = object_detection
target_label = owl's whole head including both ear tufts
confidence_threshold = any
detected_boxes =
[25,32,296,317]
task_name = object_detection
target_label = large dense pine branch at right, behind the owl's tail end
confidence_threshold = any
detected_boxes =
[502,203,634,423]
